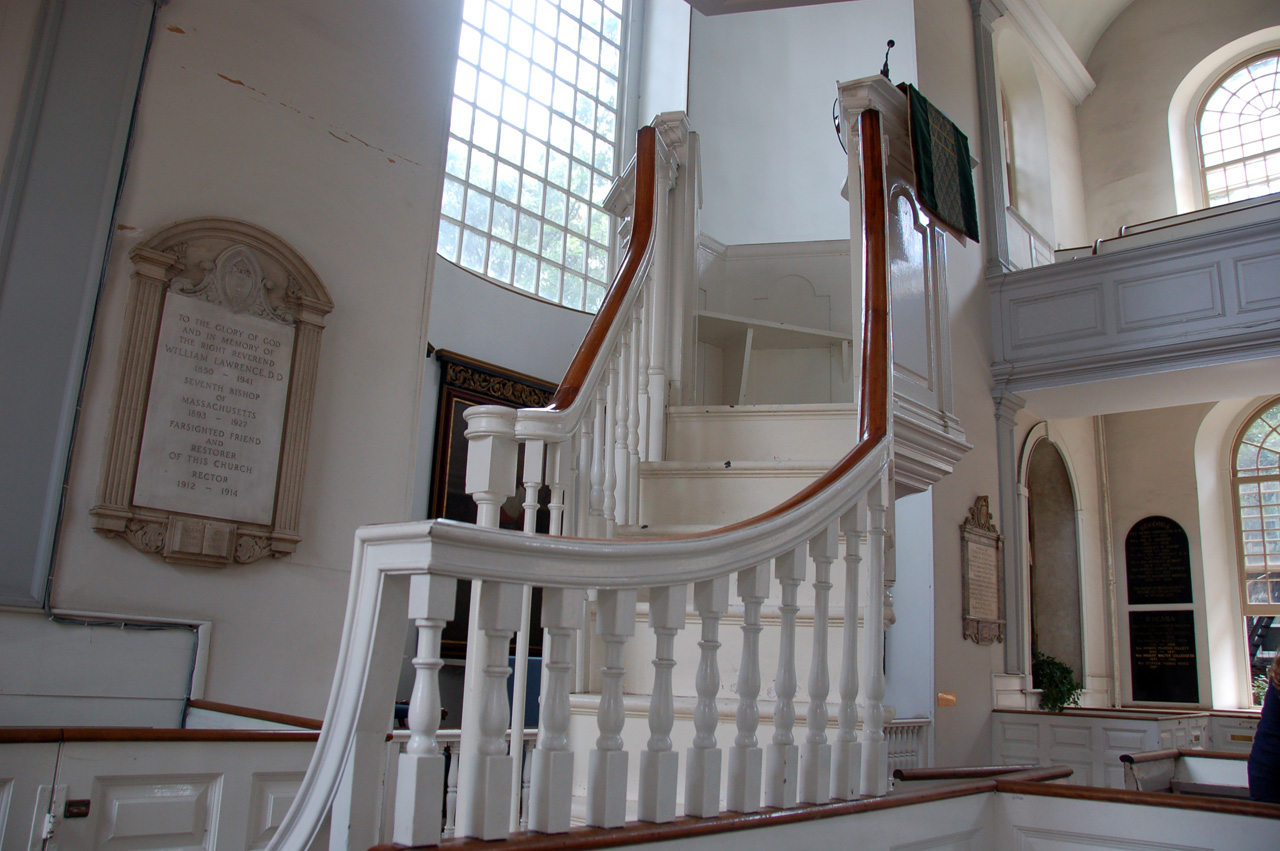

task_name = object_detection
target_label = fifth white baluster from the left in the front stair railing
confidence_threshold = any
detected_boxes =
[639,585,689,823]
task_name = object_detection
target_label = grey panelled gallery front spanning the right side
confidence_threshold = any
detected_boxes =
[988,201,1280,393]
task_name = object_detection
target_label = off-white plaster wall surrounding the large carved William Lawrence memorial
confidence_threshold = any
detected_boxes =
[31,0,461,715]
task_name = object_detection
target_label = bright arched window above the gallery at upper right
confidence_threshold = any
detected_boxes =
[1197,51,1280,207]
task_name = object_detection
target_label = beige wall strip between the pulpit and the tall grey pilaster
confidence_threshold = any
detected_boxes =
[911,0,1006,765]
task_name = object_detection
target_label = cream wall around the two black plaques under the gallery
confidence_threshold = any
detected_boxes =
[1105,404,1213,705]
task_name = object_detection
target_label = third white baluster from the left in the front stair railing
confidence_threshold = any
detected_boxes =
[529,587,586,833]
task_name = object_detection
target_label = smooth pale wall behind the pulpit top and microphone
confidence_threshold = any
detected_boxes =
[689,0,916,244]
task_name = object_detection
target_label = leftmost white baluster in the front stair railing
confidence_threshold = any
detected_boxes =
[392,573,458,845]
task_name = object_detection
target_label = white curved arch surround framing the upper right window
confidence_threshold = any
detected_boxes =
[1169,27,1280,212]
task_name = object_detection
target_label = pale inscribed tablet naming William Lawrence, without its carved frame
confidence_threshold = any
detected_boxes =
[133,292,293,525]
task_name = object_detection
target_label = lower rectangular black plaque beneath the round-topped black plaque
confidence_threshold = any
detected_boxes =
[1129,610,1199,704]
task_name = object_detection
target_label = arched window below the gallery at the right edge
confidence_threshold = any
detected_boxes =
[1231,398,1280,616]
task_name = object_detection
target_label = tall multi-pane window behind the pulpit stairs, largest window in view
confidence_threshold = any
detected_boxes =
[436,0,626,312]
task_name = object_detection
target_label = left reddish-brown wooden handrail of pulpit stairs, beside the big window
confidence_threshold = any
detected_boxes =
[545,127,658,412]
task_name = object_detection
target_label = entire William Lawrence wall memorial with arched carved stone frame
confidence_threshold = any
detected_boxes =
[90,219,333,567]
